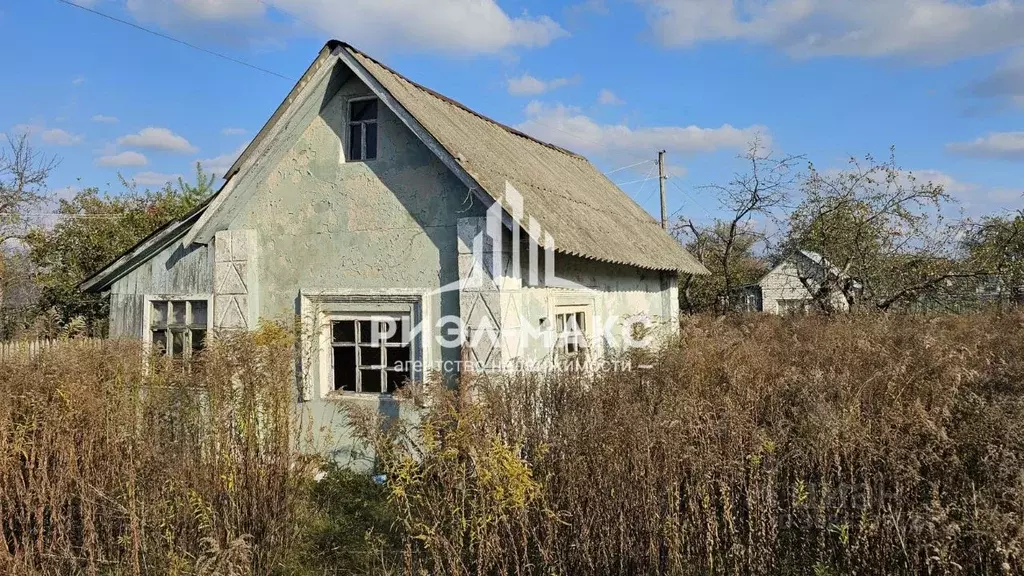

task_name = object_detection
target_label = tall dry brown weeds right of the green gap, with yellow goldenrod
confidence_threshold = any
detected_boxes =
[356,313,1024,575]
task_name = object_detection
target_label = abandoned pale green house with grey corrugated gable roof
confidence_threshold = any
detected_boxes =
[82,41,707,457]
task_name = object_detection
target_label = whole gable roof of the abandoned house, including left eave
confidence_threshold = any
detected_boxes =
[80,40,710,290]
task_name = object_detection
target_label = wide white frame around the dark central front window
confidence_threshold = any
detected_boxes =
[299,289,425,401]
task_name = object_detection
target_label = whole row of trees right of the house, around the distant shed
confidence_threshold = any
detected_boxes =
[673,138,1024,314]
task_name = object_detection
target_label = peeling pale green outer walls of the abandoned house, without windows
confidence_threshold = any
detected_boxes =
[103,63,675,463]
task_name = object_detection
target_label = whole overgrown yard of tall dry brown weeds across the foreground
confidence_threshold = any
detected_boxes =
[0,312,1024,576]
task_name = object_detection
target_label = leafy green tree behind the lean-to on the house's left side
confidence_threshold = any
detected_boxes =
[27,164,214,334]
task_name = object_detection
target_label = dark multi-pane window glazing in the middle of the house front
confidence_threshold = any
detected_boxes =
[331,317,413,394]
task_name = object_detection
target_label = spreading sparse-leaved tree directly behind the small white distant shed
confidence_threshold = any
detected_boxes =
[783,150,990,313]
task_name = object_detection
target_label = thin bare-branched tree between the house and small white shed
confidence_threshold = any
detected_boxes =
[673,135,803,312]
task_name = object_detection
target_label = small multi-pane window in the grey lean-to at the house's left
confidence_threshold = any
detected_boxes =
[150,300,210,358]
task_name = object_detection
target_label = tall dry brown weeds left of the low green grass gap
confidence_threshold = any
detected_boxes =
[0,328,308,575]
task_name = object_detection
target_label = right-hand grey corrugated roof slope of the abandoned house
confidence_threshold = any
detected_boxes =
[344,45,708,274]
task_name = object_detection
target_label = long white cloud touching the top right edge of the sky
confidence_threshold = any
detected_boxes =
[636,0,1024,61]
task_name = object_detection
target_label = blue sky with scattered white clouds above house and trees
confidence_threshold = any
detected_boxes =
[0,0,1024,219]
